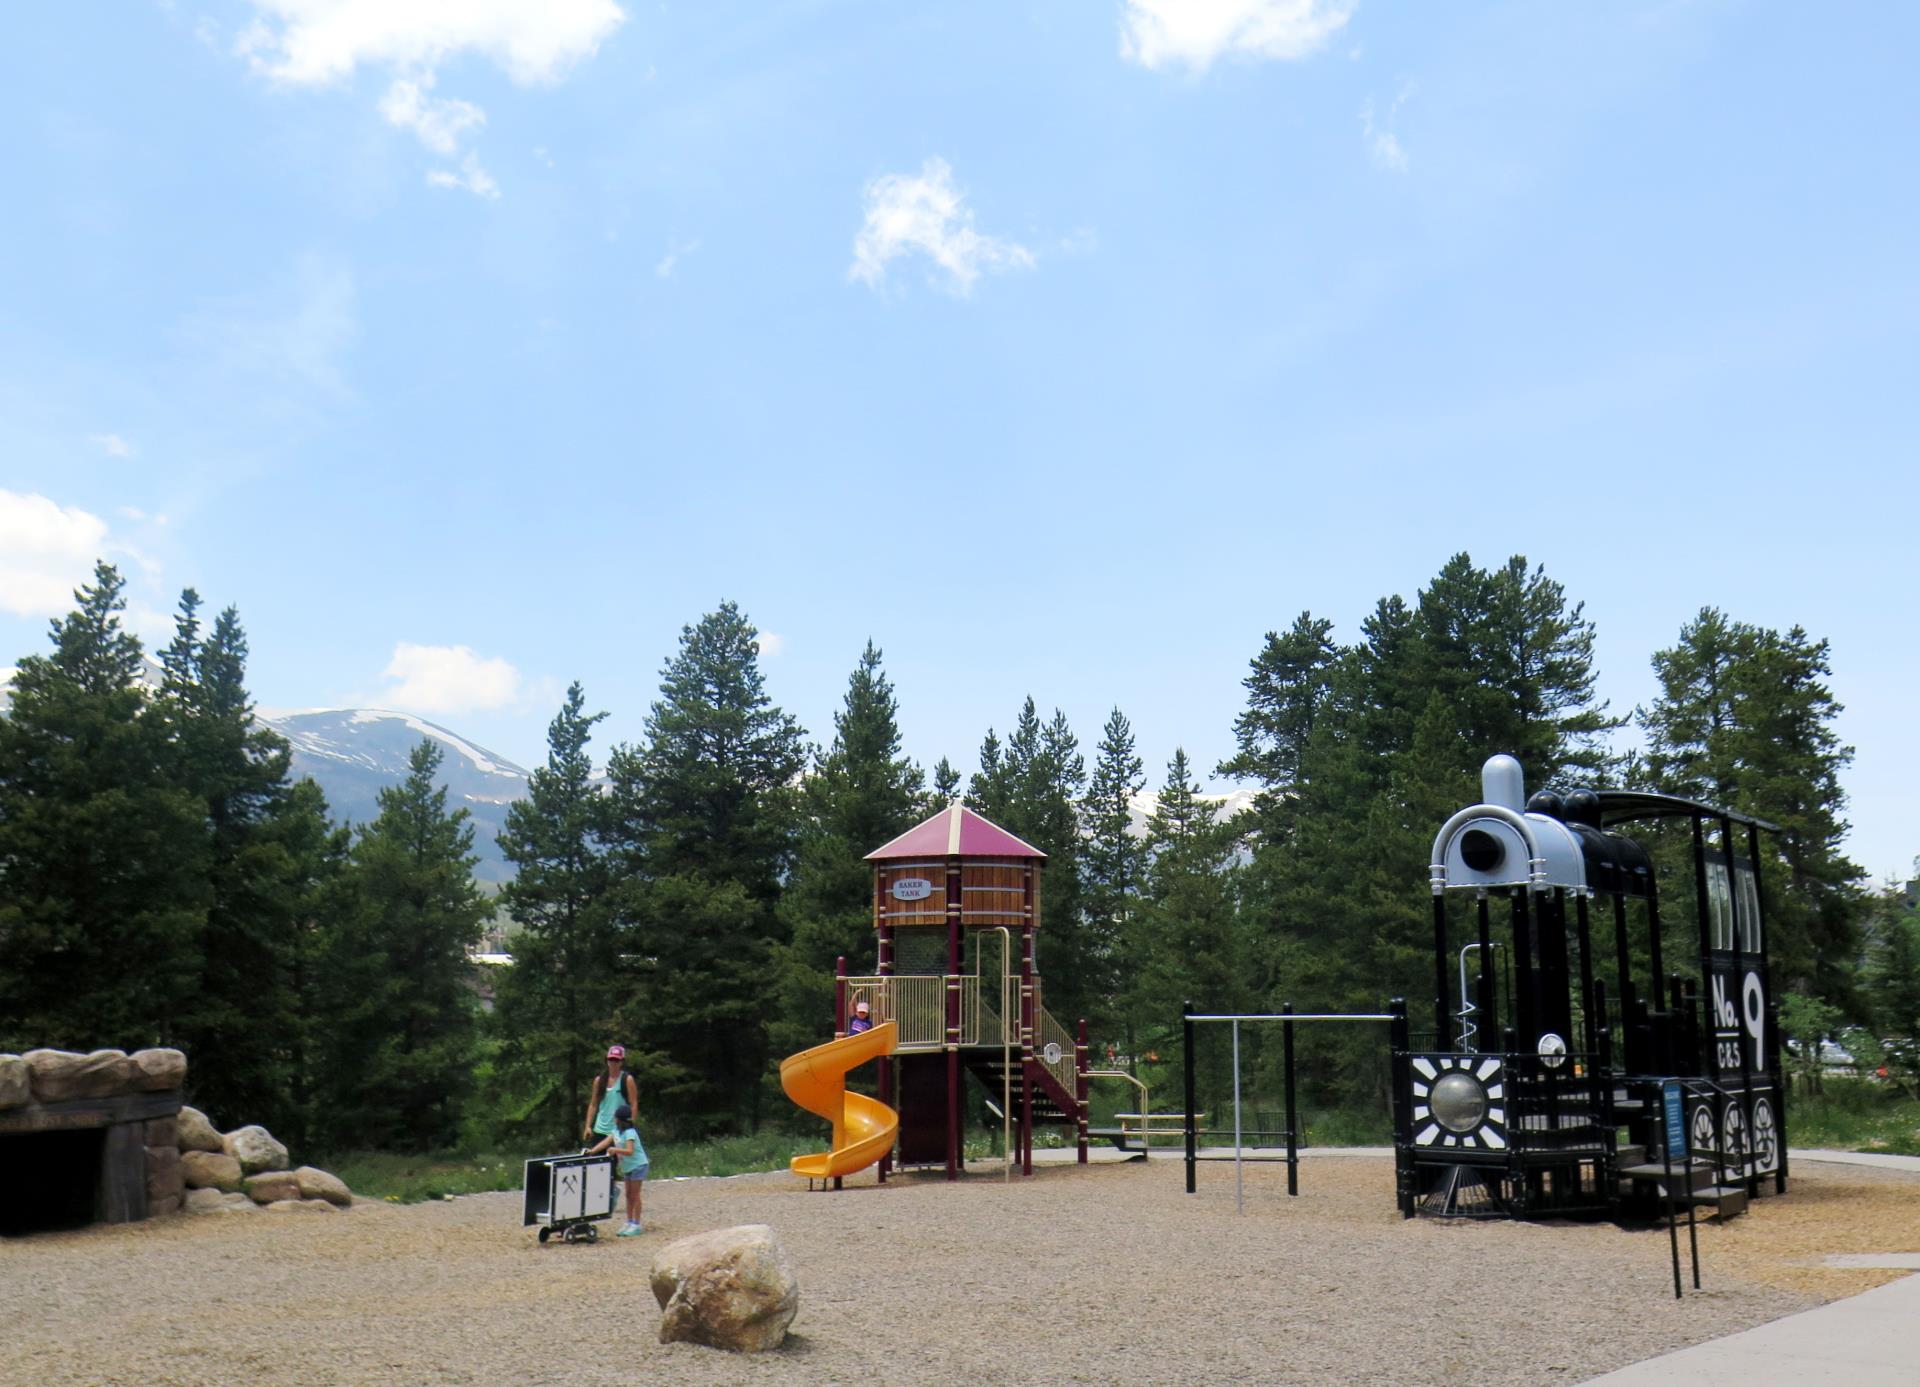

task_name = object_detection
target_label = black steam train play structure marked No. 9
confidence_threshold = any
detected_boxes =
[1394,755,1788,1218]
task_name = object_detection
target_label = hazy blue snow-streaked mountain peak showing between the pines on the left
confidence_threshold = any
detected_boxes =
[261,709,526,882]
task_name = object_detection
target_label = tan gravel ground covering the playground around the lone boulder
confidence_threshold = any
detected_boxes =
[0,1156,1920,1387]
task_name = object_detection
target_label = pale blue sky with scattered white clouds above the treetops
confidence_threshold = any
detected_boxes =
[0,0,1920,876]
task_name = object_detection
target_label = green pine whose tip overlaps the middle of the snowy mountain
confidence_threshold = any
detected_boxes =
[319,738,492,1151]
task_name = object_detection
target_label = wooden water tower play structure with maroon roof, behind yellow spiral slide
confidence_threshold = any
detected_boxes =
[835,803,1087,1180]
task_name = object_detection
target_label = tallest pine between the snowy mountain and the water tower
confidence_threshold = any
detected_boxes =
[609,601,804,1130]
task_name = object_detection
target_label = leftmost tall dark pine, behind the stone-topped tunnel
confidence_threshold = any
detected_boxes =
[0,563,207,1049]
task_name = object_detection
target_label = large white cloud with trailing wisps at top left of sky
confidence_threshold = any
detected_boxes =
[234,0,626,198]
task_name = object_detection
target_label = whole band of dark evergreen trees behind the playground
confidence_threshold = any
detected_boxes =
[0,553,1920,1153]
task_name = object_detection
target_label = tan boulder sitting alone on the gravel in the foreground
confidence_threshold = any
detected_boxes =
[647,1224,801,1352]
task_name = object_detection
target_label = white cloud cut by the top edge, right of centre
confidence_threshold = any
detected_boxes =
[1119,0,1357,73]
